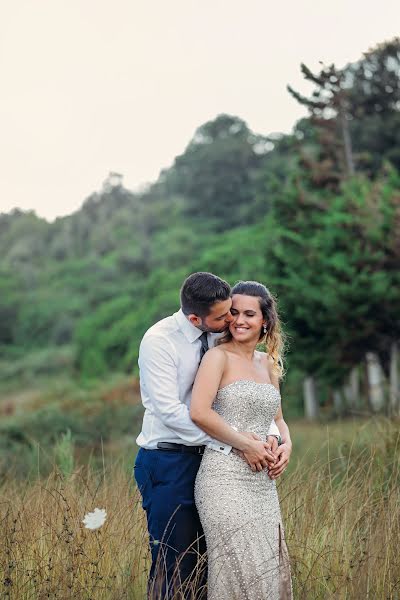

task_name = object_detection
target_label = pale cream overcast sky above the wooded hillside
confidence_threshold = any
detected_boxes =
[0,0,400,220]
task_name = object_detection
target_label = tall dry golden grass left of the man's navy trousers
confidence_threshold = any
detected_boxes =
[0,468,148,600]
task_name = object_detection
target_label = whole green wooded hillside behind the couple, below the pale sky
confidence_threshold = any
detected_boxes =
[0,38,400,426]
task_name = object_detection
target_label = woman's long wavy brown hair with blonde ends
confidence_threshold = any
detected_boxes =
[217,281,285,378]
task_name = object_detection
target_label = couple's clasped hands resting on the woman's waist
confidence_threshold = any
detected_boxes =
[239,431,292,479]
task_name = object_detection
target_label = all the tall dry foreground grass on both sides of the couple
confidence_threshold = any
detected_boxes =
[0,428,400,600]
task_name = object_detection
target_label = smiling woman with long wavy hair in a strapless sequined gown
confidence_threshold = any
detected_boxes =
[190,281,292,600]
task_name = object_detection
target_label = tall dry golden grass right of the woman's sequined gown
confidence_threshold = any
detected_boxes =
[280,430,400,600]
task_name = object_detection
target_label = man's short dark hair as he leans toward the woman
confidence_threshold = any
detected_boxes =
[181,272,231,318]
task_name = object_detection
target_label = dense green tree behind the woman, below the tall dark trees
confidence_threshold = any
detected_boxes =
[266,164,400,385]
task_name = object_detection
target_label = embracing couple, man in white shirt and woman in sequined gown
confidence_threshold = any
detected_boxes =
[134,273,292,600]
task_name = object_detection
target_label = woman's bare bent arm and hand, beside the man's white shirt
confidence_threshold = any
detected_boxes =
[190,348,275,471]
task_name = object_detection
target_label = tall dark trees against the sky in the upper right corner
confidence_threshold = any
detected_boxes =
[288,38,400,183]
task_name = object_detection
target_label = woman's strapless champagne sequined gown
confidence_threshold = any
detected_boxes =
[195,380,292,600]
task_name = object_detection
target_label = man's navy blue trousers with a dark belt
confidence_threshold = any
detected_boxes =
[134,448,207,600]
